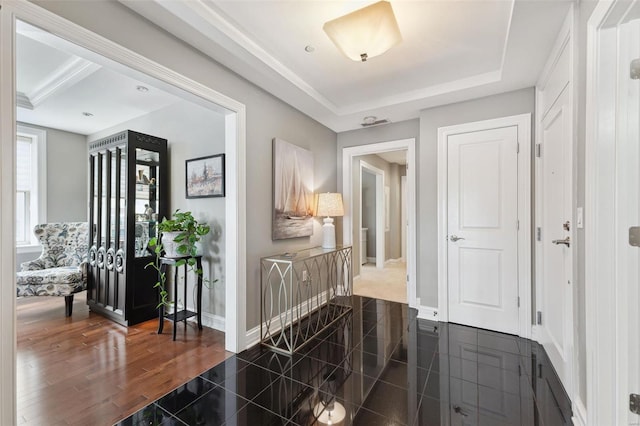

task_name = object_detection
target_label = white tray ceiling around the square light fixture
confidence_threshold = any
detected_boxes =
[120,0,571,131]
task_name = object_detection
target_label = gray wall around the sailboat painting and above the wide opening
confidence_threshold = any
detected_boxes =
[34,0,340,329]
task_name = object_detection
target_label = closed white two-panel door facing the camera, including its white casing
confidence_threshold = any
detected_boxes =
[438,114,531,338]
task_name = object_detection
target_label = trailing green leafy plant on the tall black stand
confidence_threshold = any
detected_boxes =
[145,209,218,308]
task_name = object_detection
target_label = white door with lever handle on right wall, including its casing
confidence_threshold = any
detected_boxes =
[534,9,578,407]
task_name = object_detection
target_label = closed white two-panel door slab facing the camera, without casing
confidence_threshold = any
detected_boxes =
[447,126,519,334]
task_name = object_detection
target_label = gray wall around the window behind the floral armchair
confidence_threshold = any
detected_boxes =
[16,123,89,270]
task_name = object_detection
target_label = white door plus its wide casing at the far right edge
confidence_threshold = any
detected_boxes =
[585,0,640,425]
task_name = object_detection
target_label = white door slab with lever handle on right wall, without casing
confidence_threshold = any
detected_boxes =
[537,85,573,395]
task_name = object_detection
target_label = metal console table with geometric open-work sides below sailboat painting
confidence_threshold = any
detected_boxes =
[260,246,353,354]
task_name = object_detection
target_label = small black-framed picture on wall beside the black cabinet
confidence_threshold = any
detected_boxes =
[185,154,225,198]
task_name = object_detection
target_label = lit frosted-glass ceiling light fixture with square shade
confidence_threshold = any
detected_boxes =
[322,1,402,62]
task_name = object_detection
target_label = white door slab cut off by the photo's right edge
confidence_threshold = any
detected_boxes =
[615,13,640,426]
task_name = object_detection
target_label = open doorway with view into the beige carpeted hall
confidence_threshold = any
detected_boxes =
[342,139,417,307]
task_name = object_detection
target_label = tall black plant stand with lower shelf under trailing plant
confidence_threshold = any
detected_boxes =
[158,256,202,340]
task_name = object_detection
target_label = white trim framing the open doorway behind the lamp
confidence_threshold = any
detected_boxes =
[338,138,418,308]
